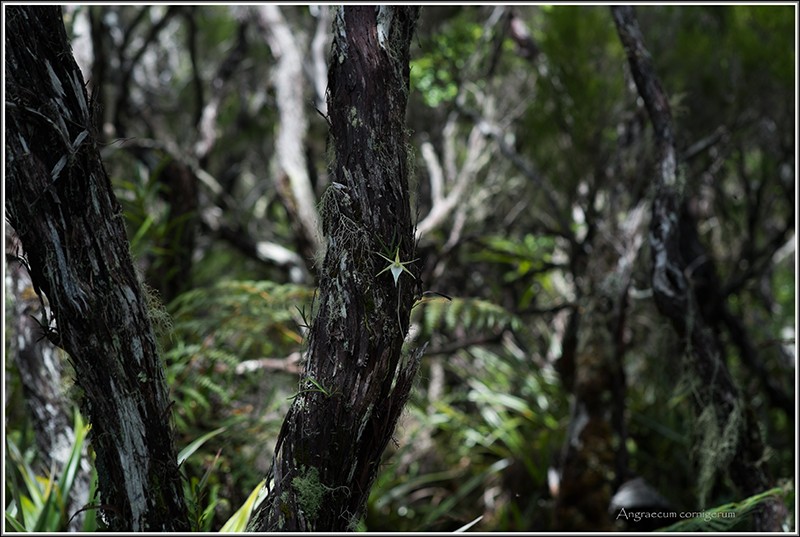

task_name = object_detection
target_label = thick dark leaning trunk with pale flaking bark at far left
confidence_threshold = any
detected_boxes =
[5,6,188,531]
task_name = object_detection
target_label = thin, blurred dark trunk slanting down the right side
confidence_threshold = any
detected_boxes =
[611,6,785,531]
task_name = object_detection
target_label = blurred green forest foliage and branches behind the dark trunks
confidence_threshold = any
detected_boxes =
[5,5,796,531]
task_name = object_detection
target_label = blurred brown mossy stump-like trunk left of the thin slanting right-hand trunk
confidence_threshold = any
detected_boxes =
[554,202,648,531]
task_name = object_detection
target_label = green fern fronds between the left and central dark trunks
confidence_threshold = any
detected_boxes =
[164,280,313,528]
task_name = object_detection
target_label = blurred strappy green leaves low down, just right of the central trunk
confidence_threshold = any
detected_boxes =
[366,345,566,531]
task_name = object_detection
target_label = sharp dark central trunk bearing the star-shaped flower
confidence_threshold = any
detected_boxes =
[251,6,421,531]
